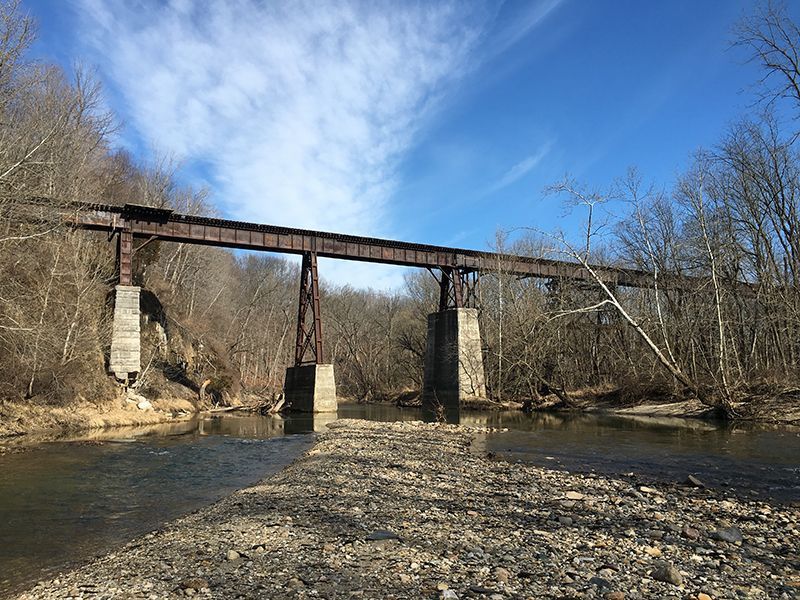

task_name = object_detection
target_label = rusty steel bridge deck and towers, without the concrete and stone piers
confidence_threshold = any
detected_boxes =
[47,199,672,365]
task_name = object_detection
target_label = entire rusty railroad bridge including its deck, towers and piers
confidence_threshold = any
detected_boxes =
[67,203,664,412]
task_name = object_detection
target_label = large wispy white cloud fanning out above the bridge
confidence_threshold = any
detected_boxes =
[72,0,564,288]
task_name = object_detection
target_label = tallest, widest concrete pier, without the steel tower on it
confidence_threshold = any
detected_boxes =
[422,308,486,410]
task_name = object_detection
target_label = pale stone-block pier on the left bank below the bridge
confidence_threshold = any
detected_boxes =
[108,285,141,381]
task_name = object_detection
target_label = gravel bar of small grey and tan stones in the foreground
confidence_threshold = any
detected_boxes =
[14,420,800,599]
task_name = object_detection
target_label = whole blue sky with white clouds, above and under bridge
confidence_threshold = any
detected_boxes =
[24,0,788,288]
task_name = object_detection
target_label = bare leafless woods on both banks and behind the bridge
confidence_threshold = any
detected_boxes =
[0,0,800,426]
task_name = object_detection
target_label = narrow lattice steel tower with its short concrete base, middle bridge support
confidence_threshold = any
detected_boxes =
[283,252,338,413]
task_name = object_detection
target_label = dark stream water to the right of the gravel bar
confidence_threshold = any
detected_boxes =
[339,405,800,503]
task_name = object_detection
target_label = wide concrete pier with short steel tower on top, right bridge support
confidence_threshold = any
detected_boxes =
[422,269,486,415]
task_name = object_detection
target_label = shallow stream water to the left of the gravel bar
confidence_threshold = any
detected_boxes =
[0,415,313,597]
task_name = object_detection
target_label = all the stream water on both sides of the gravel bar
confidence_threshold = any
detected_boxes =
[0,404,800,596]
